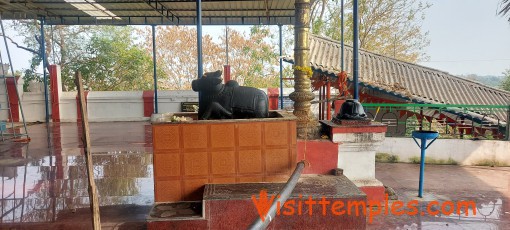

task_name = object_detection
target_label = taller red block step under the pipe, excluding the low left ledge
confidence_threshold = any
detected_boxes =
[203,175,366,229]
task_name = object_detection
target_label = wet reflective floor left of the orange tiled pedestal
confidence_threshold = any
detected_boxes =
[0,122,154,224]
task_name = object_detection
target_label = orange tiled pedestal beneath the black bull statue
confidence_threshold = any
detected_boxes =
[152,112,296,202]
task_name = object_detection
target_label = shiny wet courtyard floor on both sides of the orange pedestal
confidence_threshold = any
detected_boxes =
[0,122,510,229]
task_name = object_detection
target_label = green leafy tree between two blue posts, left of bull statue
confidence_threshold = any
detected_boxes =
[69,26,153,91]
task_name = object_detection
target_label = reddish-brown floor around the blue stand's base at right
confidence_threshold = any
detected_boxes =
[367,163,510,230]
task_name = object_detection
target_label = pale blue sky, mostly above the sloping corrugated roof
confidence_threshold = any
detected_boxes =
[2,0,510,76]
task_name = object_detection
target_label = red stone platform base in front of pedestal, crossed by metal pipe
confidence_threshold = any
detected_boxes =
[147,175,367,229]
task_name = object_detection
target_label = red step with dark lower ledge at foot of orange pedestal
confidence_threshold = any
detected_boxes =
[147,175,366,229]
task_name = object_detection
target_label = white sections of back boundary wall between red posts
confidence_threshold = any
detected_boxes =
[18,82,326,122]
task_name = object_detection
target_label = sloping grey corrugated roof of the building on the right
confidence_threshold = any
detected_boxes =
[284,35,510,120]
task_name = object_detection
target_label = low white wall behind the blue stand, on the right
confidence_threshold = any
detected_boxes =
[377,137,510,165]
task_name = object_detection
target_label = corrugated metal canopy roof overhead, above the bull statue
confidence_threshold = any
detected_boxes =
[0,0,295,25]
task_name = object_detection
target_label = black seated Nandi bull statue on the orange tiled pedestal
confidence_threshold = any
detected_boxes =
[191,70,268,120]
